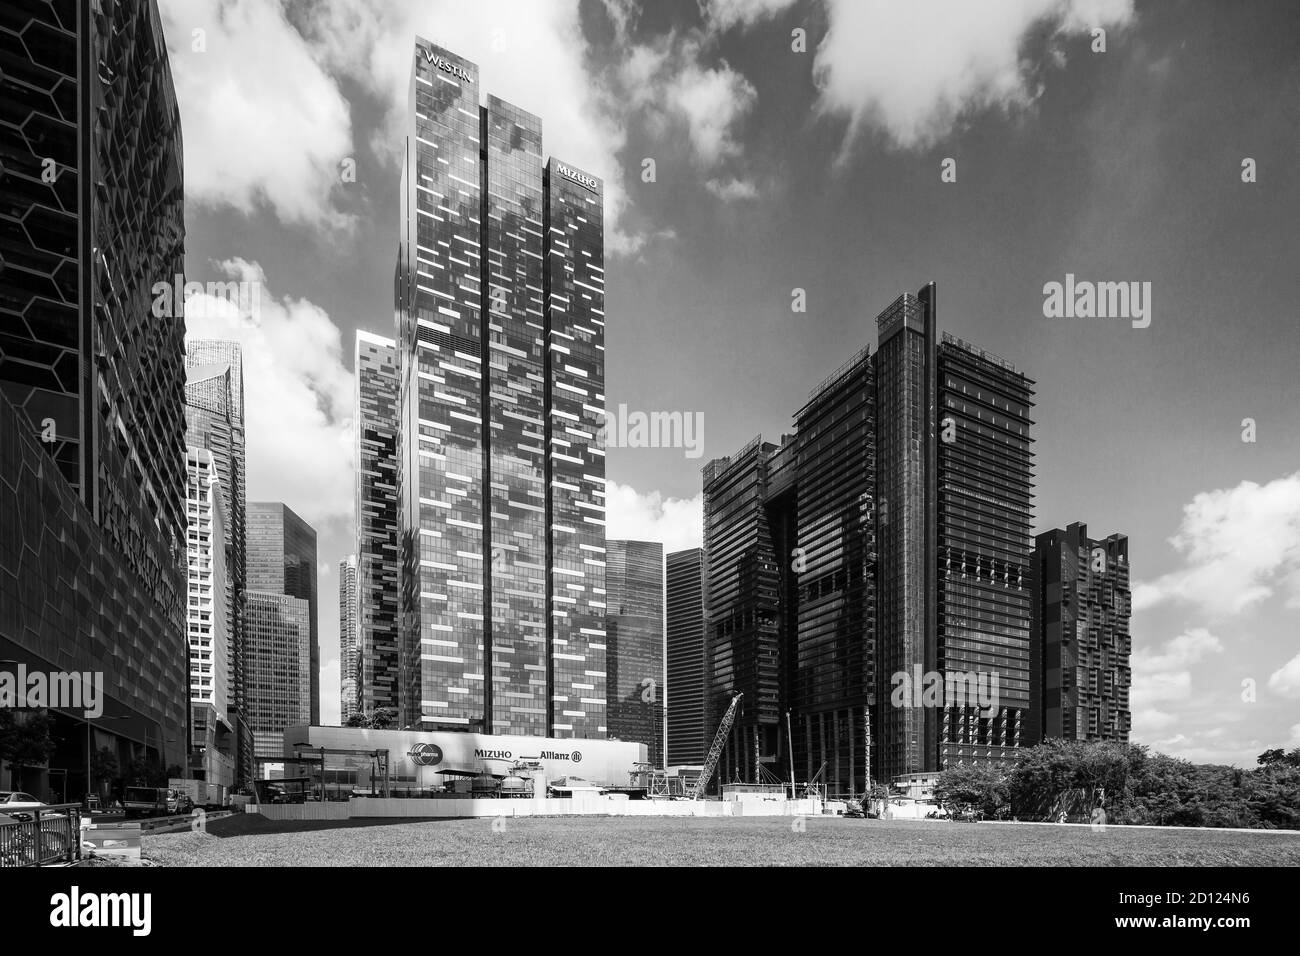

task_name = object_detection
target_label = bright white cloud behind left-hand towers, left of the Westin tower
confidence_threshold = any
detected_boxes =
[185,259,354,532]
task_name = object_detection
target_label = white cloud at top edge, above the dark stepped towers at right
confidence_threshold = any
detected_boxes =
[813,0,1134,151]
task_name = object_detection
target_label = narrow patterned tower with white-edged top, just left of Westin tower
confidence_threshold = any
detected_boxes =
[353,330,402,719]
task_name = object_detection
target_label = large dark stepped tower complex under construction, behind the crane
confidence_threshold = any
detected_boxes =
[696,284,1040,795]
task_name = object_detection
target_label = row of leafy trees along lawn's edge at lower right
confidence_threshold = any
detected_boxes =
[935,740,1300,829]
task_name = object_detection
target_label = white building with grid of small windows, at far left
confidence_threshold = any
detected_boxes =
[186,447,235,787]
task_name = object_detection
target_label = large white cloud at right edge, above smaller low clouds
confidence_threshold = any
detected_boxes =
[1134,472,1300,618]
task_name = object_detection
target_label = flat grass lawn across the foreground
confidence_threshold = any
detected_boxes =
[143,814,1300,866]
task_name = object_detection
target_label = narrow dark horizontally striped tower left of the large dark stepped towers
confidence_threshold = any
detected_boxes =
[664,548,711,766]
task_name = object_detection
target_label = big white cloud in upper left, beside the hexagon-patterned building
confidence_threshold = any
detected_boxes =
[161,0,352,229]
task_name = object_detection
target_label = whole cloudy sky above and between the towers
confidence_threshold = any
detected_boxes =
[160,0,1300,766]
